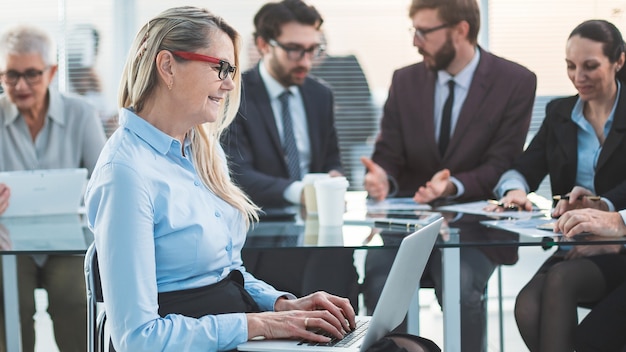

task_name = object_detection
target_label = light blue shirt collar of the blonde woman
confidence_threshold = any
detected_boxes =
[119,108,184,155]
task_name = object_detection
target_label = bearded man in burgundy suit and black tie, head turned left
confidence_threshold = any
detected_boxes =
[362,0,537,352]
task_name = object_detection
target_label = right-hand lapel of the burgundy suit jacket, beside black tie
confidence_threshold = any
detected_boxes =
[446,47,493,154]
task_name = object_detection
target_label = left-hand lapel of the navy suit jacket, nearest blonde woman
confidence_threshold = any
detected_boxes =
[242,64,283,155]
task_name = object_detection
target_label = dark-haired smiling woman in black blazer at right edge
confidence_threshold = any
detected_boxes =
[486,20,626,352]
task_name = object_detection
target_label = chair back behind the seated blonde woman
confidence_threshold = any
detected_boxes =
[85,243,108,352]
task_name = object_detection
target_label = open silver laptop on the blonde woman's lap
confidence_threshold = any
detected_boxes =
[237,218,443,352]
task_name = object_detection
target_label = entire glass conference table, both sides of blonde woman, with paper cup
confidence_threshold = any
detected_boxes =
[0,192,626,352]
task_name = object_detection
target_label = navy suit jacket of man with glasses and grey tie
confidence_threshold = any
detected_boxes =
[222,66,341,207]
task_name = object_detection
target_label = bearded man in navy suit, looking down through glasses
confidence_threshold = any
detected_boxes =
[223,0,359,314]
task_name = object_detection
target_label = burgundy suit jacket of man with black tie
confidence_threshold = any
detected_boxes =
[373,49,537,201]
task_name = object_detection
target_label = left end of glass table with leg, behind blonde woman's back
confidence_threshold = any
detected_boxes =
[0,215,93,352]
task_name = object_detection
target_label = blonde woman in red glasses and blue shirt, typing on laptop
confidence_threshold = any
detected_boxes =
[85,7,355,352]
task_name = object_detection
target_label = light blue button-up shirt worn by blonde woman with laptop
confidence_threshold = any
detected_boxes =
[85,109,293,351]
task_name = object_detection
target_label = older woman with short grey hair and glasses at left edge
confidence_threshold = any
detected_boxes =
[0,26,105,351]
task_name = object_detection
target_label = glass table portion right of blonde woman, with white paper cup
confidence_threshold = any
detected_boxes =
[244,192,626,351]
